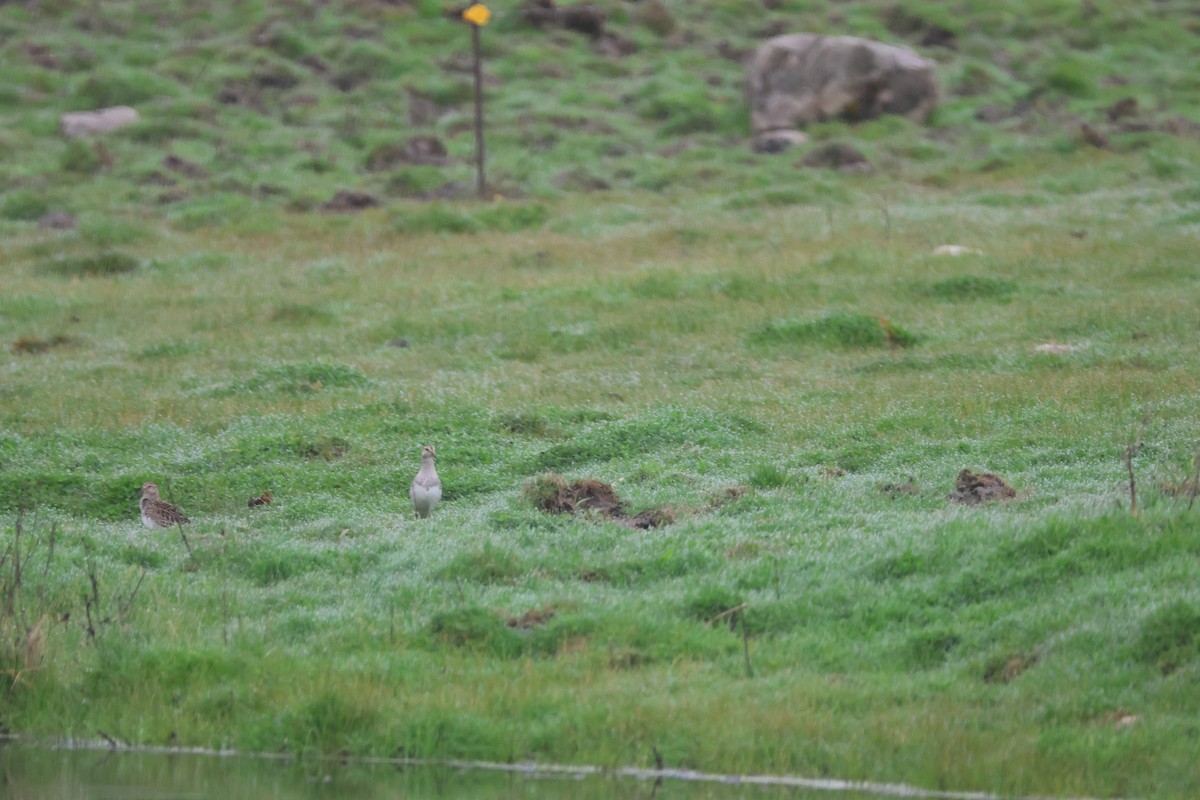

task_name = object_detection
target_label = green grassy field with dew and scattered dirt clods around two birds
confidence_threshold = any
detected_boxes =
[0,1,1200,798]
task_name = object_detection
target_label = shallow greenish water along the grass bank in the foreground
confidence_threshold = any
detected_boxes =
[0,744,912,800]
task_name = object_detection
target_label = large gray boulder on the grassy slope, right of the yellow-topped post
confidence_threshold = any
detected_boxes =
[746,34,937,142]
